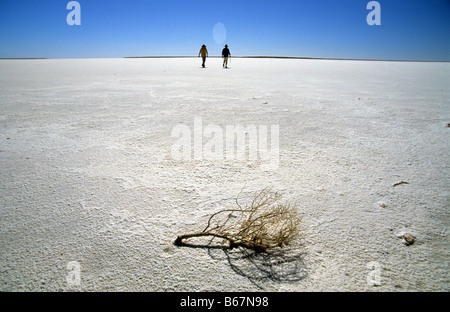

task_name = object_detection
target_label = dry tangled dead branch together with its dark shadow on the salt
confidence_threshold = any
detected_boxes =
[174,188,307,289]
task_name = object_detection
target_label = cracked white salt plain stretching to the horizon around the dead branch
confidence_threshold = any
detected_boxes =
[0,58,450,292]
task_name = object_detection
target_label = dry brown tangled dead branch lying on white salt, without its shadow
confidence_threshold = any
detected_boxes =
[174,188,301,253]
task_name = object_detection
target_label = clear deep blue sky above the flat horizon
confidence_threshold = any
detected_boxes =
[0,0,450,61]
